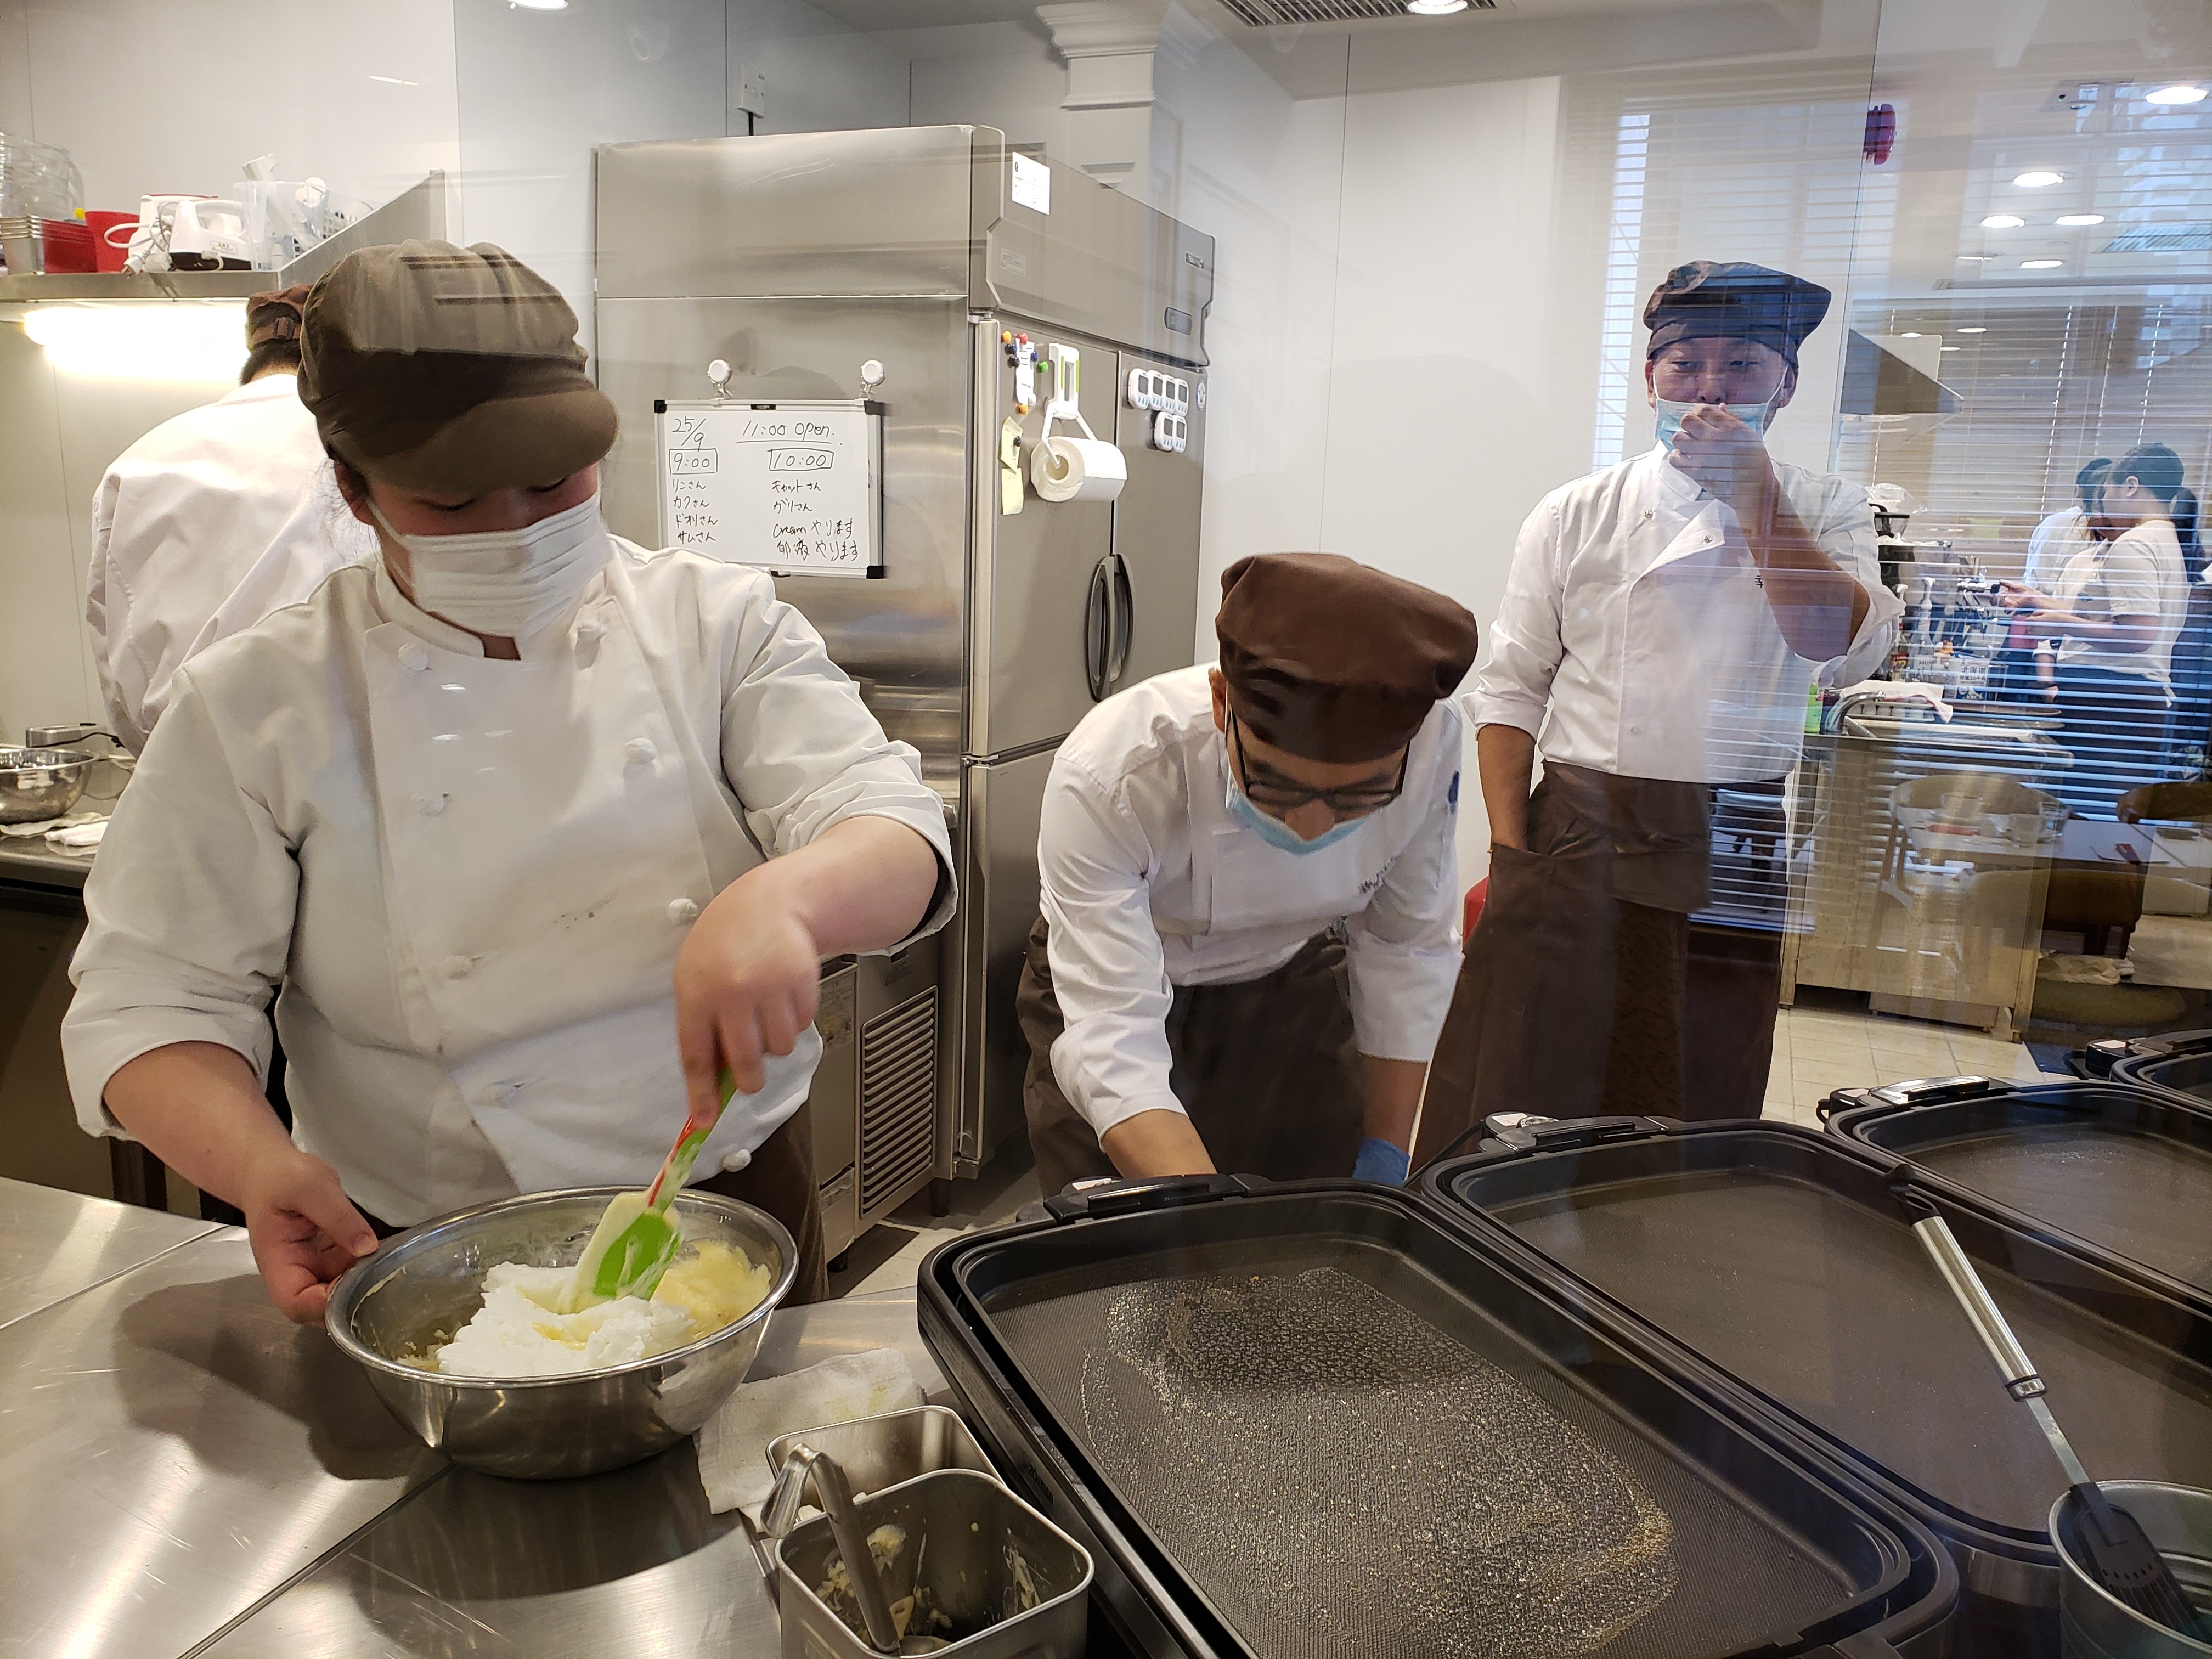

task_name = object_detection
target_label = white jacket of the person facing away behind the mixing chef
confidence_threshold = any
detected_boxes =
[84,374,376,754]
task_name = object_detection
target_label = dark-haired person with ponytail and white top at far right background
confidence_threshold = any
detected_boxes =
[2002,444,2197,819]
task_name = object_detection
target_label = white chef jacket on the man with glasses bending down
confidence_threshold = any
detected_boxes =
[1037,666,1460,1135]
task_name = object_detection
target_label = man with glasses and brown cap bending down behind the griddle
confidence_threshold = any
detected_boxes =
[1020,553,1475,1194]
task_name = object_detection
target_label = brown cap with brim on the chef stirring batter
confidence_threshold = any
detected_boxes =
[298,241,615,495]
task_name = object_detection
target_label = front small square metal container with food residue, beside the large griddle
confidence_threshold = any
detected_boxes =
[776,1469,1091,1659]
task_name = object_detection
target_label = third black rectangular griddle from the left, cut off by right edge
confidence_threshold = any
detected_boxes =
[1827,1070,2212,1307]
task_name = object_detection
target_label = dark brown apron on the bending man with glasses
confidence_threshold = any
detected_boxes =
[1015,916,1367,1197]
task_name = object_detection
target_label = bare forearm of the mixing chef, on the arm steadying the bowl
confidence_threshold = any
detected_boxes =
[106,1042,294,1203]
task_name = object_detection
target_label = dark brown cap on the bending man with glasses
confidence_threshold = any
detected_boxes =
[1215,553,1475,765]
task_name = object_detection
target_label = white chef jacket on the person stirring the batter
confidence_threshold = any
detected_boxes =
[62,538,951,1226]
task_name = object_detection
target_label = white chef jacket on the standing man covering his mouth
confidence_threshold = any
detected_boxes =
[1466,447,1903,783]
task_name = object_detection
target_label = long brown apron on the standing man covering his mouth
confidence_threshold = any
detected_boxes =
[1413,765,1781,1168]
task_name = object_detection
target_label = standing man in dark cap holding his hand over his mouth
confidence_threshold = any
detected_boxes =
[1415,261,1898,1161]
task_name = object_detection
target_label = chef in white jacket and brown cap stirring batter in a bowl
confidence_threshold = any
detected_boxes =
[62,241,951,1321]
